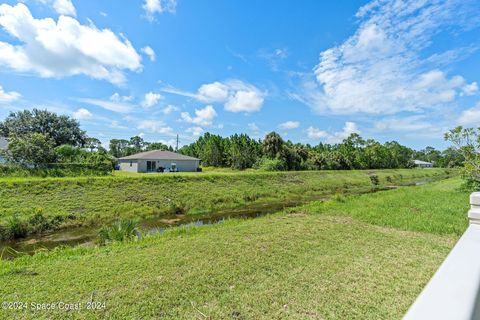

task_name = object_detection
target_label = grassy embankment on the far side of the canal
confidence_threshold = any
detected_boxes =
[0,169,451,238]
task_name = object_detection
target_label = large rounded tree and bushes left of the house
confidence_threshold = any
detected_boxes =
[0,109,114,177]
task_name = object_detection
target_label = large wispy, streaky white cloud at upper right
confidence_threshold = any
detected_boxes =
[294,0,476,114]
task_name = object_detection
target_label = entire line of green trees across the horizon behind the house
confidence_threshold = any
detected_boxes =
[0,109,465,171]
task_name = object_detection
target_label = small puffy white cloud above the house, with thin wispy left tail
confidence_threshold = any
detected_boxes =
[163,80,266,113]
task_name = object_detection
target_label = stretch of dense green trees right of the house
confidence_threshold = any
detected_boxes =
[179,132,463,171]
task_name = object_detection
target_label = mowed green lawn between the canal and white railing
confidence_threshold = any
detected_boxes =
[0,178,468,319]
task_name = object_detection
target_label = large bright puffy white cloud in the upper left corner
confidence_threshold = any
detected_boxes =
[0,3,142,84]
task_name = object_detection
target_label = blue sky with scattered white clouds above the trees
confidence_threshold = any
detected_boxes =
[0,0,480,148]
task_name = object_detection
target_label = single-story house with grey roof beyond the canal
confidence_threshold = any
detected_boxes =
[118,150,200,172]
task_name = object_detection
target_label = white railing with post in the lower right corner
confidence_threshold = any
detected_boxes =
[404,192,480,320]
